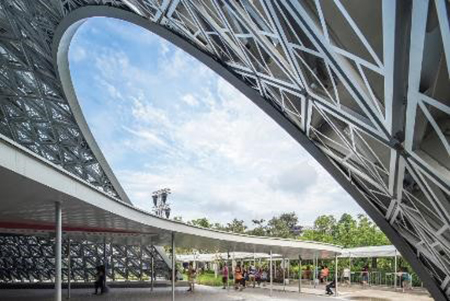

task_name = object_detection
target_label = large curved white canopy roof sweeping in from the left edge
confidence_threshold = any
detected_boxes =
[0,136,341,259]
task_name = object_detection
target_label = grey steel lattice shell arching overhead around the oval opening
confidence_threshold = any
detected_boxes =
[0,0,450,299]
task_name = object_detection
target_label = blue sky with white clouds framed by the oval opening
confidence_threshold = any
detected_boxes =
[69,18,362,225]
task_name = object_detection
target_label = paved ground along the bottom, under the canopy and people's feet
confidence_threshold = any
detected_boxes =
[0,285,432,301]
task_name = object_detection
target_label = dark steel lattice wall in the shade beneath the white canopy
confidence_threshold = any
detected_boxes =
[0,234,171,283]
